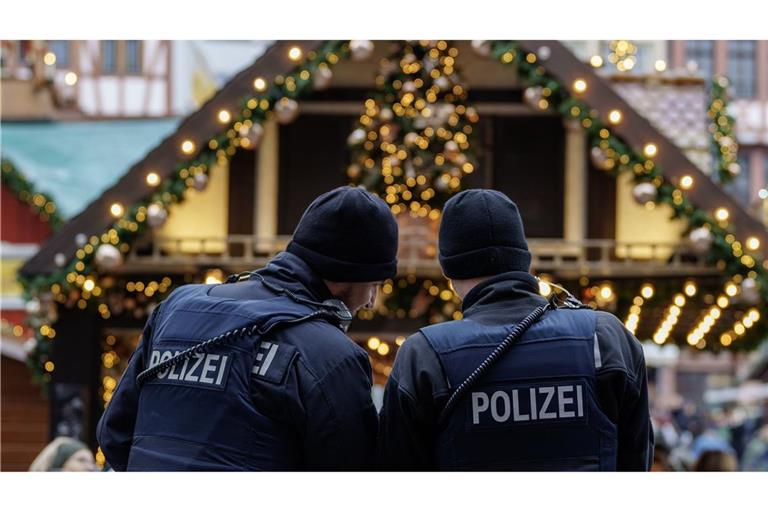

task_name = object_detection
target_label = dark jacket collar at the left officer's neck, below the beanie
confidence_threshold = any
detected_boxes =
[256,252,333,302]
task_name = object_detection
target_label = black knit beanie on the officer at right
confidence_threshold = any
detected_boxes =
[439,189,531,279]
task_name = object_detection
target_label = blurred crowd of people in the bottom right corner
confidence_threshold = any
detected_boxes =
[652,401,768,471]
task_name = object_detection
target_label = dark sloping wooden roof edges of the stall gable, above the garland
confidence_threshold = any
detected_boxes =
[21,40,768,275]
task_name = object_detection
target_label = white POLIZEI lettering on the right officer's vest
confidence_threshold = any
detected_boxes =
[471,384,584,426]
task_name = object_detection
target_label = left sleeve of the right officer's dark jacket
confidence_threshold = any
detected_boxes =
[378,333,449,471]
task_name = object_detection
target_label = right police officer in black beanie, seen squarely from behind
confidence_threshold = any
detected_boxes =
[379,190,653,471]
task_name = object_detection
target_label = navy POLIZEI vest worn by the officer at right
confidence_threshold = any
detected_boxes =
[421,309,617,471]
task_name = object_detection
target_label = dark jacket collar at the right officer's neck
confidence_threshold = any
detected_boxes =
[462,271,547,316]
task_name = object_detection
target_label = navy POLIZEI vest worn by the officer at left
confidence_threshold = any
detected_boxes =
[128,285,328,471]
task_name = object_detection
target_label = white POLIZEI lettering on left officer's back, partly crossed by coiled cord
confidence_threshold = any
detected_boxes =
[149,350,230,389]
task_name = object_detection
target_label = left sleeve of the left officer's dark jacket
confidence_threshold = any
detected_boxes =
[96,308,159,471]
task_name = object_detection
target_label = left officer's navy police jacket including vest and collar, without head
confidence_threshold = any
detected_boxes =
[97,252,377,471]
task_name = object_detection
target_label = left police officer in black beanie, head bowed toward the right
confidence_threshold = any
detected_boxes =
[97,187,397,471]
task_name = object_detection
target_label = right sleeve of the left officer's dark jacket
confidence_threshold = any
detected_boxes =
[302,342,378,471]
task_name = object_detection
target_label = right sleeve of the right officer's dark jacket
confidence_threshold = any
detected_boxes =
[597,314,654,471]
